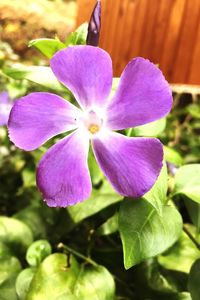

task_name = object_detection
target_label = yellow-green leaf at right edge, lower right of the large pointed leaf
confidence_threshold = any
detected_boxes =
[158,226,200,273]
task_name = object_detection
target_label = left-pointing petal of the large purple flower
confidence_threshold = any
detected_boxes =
[8,93,79,151]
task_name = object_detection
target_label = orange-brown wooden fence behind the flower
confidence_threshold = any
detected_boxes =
[77,0,200,84]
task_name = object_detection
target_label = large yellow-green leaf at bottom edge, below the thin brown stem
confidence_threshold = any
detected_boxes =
[27,254,115,300]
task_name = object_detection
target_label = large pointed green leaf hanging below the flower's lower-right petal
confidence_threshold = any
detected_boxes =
[119,199,182,269]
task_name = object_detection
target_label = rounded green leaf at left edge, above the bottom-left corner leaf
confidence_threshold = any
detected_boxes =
[0,217,33,254]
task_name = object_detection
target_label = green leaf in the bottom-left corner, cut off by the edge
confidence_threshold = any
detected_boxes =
[0,256,21,300]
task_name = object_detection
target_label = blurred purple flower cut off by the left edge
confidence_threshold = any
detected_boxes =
[0,91,13,126]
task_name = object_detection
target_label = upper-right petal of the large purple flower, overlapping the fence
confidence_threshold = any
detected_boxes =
[107,57,172,130]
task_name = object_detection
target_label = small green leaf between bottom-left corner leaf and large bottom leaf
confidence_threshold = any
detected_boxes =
[15,268,36,300]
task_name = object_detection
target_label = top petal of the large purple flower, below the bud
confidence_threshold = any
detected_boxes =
[50,46,112,108]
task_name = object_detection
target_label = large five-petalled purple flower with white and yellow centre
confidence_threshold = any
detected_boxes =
[9,46,172,207]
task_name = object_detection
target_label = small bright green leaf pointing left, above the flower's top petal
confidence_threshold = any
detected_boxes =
[28,39,66,58]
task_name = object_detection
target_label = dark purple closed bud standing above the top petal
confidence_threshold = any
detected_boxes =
[87,0,101,47]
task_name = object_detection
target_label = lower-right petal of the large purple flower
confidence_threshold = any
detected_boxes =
[92,132,163,197]
